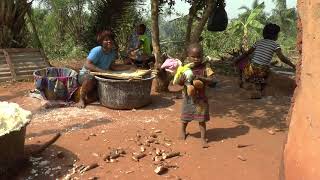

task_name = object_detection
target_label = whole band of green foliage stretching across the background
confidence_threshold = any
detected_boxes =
[24,0,297,64]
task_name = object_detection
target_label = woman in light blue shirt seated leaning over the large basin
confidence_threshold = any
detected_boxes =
[77,30,130,108]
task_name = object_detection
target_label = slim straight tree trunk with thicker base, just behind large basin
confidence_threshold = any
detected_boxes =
[151,0,170,92]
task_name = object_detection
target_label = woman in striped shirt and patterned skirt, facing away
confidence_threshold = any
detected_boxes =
[236,23,295,98]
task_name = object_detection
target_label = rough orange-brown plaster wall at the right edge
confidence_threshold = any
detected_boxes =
[284,0,320,180]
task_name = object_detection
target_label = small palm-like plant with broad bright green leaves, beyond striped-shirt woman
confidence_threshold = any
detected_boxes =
[231,2,265,50]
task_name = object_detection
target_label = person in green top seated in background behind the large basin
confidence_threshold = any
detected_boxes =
[127,24,154,67]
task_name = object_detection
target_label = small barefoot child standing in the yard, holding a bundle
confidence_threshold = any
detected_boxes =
[180,44,213,148]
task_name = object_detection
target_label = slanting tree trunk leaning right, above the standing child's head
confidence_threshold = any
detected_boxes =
[190,0,216,43]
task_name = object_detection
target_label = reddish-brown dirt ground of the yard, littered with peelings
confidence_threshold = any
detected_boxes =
[0,76,290,180]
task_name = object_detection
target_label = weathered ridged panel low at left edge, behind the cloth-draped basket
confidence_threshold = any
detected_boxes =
[0,48,50,82]
